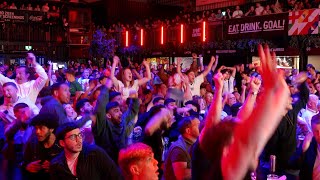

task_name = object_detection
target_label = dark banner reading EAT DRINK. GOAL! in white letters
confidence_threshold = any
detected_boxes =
[224,13,288,39]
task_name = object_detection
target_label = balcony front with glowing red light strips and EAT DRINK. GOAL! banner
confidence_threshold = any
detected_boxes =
[107,13,289,49]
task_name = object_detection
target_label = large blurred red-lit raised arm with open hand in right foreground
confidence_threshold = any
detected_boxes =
[221,45,289,180]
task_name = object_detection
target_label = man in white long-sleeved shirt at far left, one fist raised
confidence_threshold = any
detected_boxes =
[0,53,48,103]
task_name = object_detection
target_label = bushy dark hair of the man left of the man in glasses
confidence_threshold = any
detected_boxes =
[30,113,59,129]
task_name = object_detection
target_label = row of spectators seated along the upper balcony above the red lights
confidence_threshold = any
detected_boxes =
[95,0,320,36]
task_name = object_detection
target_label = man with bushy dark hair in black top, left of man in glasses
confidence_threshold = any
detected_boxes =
[23,113,62,179]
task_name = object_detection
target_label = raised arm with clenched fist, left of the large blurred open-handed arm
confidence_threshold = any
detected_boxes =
[199,72,223,146]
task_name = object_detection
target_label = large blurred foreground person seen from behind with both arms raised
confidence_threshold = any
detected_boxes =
[192,45,289,180]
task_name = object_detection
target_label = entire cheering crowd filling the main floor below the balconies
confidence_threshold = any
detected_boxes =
[0,46,320,179]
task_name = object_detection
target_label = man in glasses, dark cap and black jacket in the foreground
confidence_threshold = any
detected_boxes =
[50,122,122,180]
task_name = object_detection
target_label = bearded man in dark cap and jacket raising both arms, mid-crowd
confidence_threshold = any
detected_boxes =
[92,86,139,162]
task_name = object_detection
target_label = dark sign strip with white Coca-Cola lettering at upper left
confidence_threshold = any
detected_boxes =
[0,9,44,23]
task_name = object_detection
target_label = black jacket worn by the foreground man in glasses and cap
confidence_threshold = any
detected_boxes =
[50,145,123,180]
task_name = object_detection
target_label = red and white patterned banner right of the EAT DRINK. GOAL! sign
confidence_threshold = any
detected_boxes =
[288,9,320,36]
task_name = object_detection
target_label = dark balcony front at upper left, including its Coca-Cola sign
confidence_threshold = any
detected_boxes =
[0,9,68,43]
